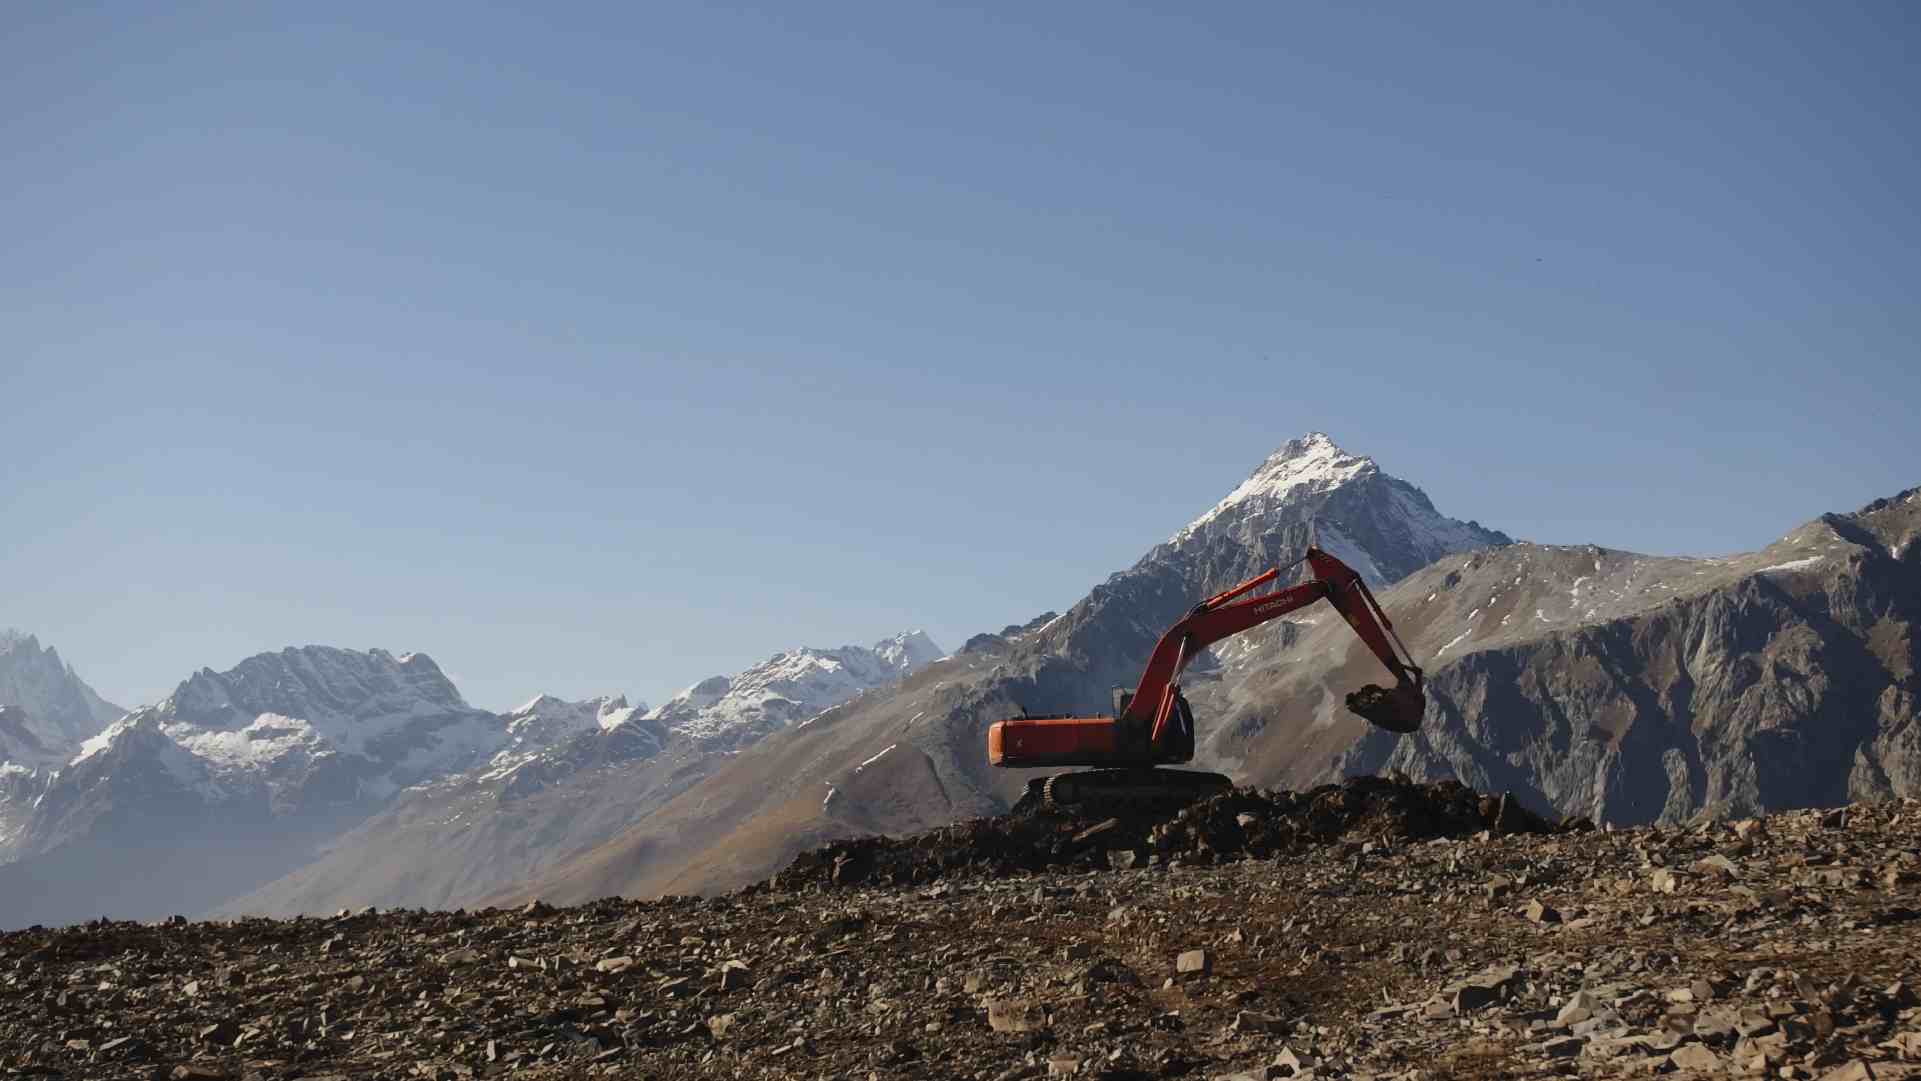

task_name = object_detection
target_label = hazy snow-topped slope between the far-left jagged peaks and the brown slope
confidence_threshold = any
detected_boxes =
[221,632,941,914]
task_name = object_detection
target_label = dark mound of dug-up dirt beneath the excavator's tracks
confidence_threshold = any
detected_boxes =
[772,778,1587,889]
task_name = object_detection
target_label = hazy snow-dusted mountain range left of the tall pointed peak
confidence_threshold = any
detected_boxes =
[0,632,939,925]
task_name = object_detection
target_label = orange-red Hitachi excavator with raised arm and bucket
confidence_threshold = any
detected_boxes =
[987,547,1427,806]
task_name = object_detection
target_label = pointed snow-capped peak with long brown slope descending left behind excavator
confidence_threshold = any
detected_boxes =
[501,432,1510,899]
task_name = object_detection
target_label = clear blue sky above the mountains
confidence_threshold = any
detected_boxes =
[0,2,1921,709]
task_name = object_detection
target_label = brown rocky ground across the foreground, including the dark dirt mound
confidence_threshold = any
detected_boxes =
[0,780,1921,1081]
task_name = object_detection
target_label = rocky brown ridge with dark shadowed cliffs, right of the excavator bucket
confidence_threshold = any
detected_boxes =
[1306,490,1921,824]
